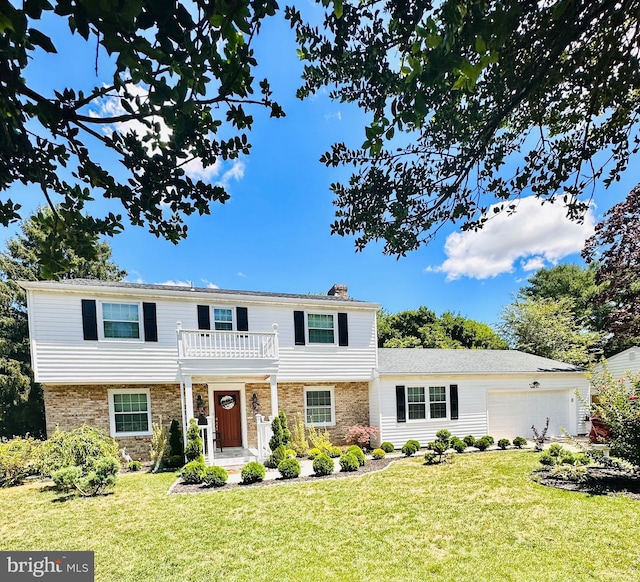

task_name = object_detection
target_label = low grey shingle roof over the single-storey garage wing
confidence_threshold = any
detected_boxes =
[378,348,584,375]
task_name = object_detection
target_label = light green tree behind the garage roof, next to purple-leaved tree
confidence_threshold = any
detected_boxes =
[498,296,603,365]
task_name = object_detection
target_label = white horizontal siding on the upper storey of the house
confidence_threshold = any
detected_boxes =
[28,289,376,383]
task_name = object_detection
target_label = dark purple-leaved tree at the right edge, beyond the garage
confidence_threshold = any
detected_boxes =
[582,186,640,355]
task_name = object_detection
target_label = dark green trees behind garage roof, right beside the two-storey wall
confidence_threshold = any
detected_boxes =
[378,306,508,350]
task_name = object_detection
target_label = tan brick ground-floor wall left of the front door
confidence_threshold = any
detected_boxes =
[44,384,182,461]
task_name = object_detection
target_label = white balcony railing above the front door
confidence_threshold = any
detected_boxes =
[177,325,278,360]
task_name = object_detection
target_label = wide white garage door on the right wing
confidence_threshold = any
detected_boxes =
[488,390,576,439]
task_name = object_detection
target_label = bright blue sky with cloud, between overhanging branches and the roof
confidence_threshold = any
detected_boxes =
[2,8,638,324]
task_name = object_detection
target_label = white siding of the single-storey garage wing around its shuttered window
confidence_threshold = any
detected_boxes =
[372,373,588,448]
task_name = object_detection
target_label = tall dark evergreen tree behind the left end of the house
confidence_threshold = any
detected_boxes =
[0,209,127,437]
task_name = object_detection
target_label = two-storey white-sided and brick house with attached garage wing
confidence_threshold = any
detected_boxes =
[21,279,588,462]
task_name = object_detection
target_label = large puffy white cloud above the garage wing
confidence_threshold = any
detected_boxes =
[426,196,595,281]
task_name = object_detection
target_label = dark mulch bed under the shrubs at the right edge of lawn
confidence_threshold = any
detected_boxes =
[533,467,640,500]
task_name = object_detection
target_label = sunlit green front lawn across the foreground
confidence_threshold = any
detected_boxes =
[0,451,640,582]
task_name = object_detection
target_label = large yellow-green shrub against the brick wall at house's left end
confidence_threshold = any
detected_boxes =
[37,424,119,477]
